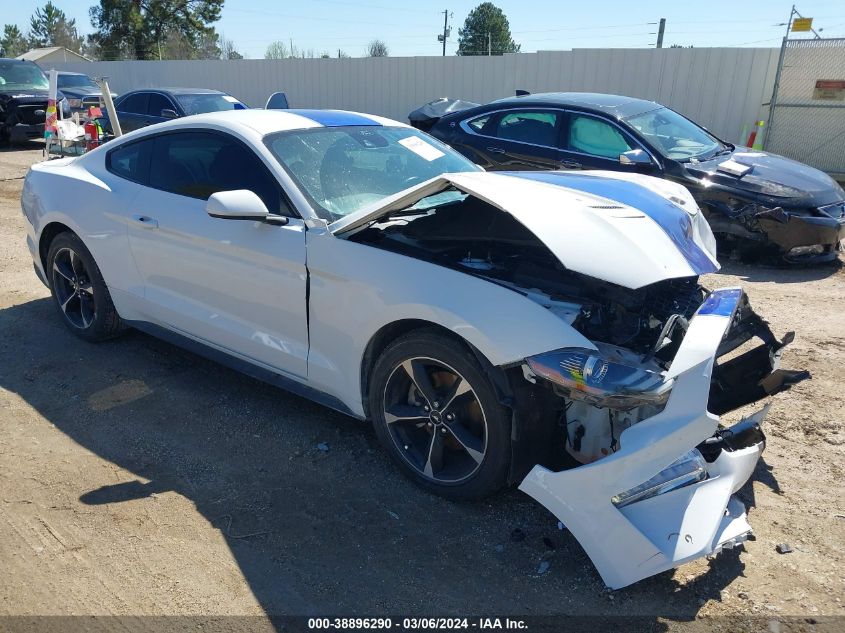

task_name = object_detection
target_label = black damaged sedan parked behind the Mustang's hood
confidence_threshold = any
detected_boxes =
[415,93,845,263]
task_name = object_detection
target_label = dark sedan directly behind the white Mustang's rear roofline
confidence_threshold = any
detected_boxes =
[101,88,247,132]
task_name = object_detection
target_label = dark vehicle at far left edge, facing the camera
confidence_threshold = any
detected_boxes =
[0,59,70,144]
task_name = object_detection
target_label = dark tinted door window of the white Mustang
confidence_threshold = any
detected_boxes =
[150,132,294,215]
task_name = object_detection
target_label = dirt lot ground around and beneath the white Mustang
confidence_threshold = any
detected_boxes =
[0,143,845,630]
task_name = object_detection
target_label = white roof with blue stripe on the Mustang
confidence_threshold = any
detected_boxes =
[114,109,410,137]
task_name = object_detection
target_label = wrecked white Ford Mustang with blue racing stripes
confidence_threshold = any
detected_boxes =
[22,110,806,588]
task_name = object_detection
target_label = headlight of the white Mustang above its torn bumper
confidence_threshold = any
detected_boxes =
[525,348,672,411]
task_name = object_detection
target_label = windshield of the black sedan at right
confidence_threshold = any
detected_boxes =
[626,108,726,162]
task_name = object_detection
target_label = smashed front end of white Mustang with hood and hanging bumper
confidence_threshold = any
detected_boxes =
[330,173,808,588]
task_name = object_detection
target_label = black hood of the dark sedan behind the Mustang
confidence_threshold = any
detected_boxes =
[685,147,845,206]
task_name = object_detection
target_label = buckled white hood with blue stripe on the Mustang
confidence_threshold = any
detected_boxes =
[329,172,719,288]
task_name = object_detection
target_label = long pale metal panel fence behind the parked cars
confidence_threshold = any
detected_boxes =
[55,48,778,142]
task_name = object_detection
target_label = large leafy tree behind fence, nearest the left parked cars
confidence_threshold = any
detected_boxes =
[90,0,223,59]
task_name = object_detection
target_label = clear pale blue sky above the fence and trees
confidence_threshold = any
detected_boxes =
[0,0,845,58]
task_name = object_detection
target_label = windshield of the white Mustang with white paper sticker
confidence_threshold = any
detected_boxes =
[264,126,481,222]
